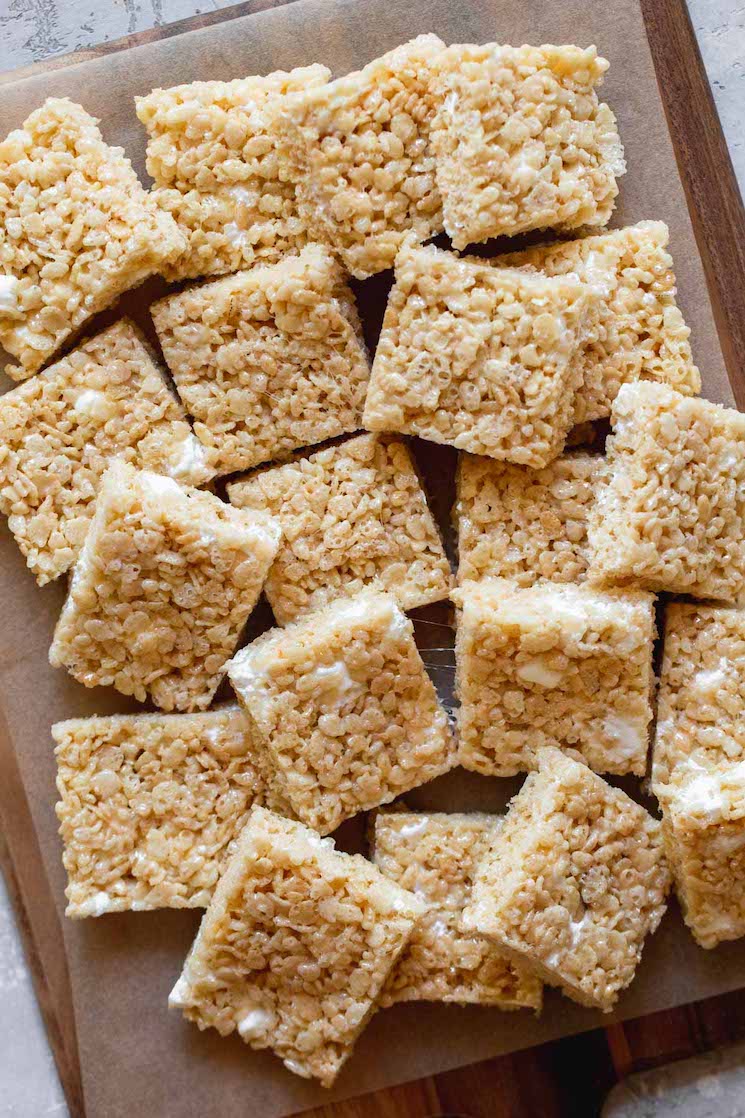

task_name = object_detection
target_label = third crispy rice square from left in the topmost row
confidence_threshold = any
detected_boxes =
[276,35,444,280]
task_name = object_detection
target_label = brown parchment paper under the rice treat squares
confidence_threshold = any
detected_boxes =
[0,0,745,1118]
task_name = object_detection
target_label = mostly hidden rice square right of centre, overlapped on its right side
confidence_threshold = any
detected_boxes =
[453,453,603,586]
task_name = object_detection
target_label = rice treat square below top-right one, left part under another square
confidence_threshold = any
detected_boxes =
[493,221,701,424]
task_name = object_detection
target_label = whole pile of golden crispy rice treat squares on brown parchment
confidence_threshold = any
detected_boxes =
[0,35,745,1086]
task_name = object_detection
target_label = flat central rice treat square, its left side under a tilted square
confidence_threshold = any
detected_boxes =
[228,435,452,625]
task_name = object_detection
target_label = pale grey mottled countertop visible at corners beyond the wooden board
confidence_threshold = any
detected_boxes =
[0,0,745,1118]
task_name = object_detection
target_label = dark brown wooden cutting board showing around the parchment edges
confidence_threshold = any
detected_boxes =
[0,0,745,1118]
